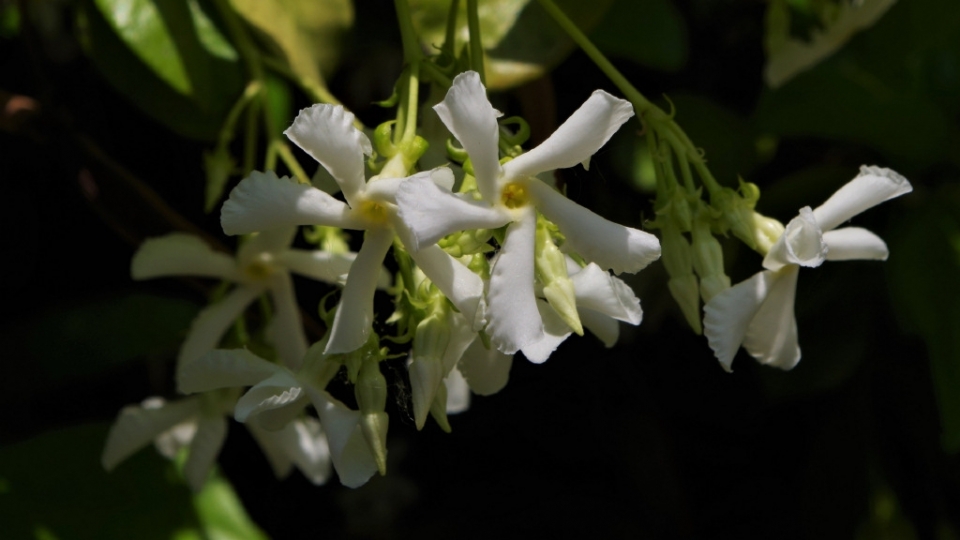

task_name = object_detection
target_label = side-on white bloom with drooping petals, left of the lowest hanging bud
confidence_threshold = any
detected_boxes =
[178,349,377,487]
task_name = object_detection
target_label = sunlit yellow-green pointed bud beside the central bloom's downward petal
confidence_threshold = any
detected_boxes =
[534,216,583,336]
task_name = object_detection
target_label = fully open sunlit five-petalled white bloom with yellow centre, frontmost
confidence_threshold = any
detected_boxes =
[397,71,660,354]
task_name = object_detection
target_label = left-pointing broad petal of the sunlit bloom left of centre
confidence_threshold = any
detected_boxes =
[220,171,366,235]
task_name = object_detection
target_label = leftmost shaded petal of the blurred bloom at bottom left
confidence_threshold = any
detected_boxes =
[100,398,200,471]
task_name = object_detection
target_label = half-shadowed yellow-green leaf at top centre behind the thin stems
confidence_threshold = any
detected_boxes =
[410,0,613,90]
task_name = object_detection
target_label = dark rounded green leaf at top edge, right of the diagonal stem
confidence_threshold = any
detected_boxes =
[590,0,688,71]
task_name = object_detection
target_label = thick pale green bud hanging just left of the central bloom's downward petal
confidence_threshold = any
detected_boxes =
[407,310,450,430]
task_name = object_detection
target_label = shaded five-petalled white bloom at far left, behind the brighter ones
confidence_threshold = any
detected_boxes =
[130,227,378,369]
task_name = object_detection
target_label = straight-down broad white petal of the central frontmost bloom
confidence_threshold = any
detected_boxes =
[487,212,543,354]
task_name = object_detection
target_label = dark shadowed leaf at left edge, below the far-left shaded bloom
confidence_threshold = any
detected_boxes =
[0,294,198,401]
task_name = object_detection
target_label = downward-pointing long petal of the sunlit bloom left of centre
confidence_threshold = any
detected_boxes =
[324,228,393,354]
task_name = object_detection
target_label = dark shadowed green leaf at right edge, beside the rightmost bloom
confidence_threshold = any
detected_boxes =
[888,184,960,452]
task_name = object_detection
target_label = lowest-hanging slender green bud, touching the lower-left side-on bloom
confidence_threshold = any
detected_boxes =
[353,358,389,475]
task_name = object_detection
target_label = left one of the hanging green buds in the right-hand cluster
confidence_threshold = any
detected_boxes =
[658,216,703,335]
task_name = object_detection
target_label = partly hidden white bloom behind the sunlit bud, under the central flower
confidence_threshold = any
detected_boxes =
[523,257,643,361]
